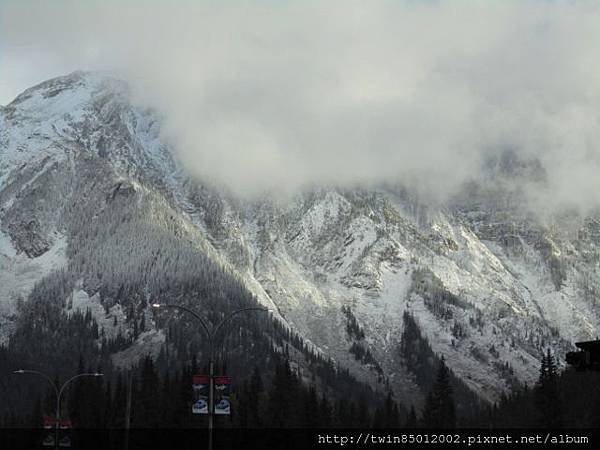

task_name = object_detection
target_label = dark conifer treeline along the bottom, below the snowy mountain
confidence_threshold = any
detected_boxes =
[0,315,600,429]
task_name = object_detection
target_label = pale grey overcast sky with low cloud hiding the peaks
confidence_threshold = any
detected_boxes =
[0,0,600,208]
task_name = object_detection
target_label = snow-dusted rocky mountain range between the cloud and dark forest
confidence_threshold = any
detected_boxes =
[0,72,600,404]
